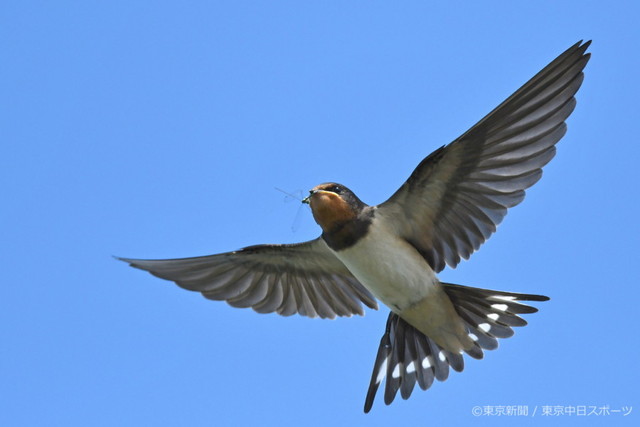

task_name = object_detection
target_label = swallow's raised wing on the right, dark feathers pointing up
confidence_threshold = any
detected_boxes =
[378,42,590,272]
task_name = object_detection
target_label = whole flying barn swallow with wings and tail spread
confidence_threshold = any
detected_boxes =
[119,42,590,412]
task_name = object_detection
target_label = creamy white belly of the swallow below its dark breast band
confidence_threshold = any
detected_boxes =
[335,218,438,313]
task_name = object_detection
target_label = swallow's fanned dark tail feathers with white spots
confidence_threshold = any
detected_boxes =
[364,283,549,413]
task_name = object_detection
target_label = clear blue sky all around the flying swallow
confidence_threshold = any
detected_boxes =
[0,0,640,426]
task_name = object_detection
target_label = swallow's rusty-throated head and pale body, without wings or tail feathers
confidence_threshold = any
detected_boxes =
[309,194,473,353]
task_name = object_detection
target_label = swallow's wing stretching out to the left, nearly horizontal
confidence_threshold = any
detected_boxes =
[118,238,378,319]
